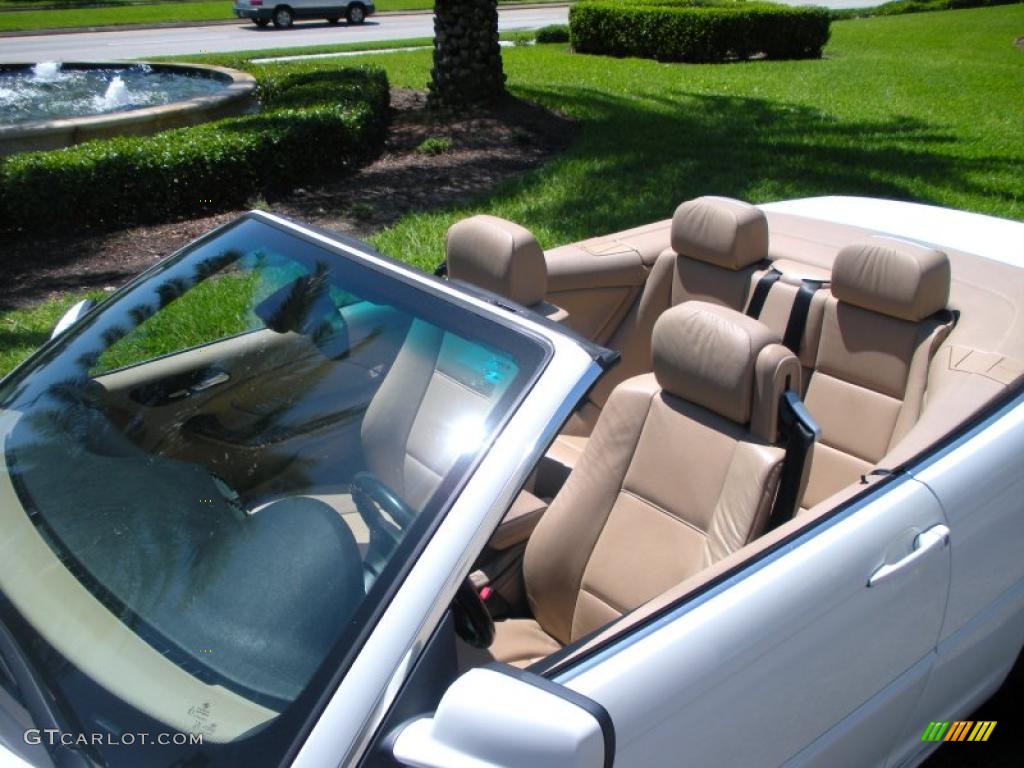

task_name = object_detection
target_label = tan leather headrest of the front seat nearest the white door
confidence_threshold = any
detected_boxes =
[651,301,801,442]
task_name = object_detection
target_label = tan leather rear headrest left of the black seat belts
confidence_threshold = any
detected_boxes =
[672,198,768,269]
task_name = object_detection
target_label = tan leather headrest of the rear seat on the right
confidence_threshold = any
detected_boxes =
[831,238,949,323]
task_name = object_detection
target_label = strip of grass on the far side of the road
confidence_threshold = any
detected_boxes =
[0,0,565,32]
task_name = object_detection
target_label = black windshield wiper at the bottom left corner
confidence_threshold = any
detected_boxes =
[0,624,104,768]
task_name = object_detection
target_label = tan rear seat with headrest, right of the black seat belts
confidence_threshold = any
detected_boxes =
[801,238,951,508]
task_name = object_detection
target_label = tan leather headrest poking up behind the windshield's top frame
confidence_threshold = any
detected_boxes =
[444,216,548,306]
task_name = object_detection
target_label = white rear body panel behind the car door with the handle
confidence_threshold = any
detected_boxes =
[890,397,1024,765]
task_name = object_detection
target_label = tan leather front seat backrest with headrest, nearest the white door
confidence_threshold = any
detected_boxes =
[523,301,800,643]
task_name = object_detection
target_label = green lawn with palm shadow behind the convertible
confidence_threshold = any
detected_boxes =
[0,5,1024,378]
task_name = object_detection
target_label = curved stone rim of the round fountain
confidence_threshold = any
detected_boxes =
[0,61,257,156]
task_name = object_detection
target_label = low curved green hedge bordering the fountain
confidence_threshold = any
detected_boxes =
[0,68,389,233]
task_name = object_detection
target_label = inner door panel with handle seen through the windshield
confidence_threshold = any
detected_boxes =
[96,302,408,493]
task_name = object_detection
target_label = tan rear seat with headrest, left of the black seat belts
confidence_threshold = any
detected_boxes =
[590,197,768,408]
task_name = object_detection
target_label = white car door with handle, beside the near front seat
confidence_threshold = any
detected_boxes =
[556,476,949,766]
